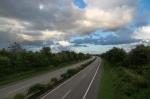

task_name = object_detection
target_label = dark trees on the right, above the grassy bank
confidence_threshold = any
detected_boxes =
[101,45,150,67]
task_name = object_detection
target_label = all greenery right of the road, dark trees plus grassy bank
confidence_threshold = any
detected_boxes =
[100,45,150,99]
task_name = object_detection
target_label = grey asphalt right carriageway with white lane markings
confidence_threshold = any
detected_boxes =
[40,58,101,99]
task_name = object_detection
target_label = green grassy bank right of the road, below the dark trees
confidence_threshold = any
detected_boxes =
[99,61,150,99]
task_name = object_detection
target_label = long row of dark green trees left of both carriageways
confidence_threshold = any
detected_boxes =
[0,43,89,78]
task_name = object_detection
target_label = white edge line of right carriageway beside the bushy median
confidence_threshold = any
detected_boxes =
[41,58,95,99]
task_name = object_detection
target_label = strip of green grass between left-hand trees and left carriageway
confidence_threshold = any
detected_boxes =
[0,60,83,86]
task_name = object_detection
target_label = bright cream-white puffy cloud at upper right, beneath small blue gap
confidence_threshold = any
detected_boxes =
[78,0,137,29]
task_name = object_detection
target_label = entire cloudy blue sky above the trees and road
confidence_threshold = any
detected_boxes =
[0,0,150,54]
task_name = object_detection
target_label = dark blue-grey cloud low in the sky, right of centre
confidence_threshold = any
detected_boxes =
[72,28,140,45]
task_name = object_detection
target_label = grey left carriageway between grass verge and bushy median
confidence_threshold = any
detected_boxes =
[0,58,93,99]
